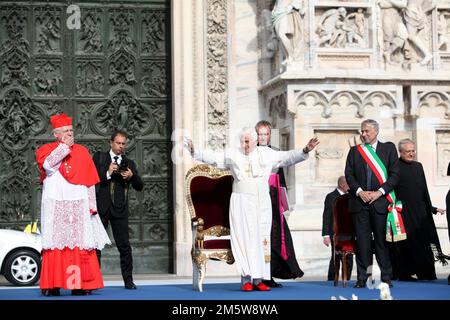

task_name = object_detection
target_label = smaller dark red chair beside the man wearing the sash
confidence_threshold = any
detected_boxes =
[333,194,356,287]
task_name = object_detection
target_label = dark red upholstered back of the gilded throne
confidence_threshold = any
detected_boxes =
[190,175,233,230]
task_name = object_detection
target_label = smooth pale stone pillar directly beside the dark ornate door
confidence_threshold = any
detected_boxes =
[171,0,207,276]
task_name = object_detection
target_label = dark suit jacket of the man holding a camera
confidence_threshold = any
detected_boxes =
[93,151,144,217]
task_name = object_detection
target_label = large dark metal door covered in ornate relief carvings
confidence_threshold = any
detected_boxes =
[0,0,173,273]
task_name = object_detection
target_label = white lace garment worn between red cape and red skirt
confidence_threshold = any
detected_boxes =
[41,144,111,250]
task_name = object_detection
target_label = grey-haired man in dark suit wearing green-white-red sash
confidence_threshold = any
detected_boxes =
[345,119,399,288]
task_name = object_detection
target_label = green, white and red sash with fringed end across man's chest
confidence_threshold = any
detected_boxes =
[357,144,406,242]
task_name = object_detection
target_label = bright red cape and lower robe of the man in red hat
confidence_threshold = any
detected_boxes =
[36,142,109,290]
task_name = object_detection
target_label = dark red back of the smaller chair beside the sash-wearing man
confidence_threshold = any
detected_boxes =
[333,194,356,253]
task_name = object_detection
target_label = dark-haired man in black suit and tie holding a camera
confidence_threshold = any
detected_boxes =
[93,130,144,289]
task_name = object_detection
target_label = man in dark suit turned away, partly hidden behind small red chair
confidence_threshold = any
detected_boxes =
[322,176,353,281]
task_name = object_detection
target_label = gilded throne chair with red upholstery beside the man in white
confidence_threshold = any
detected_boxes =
[186,164,234,292]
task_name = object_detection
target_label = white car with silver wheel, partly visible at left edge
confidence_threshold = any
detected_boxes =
[0,230,42,286]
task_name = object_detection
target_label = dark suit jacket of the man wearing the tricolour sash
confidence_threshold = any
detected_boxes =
[345,141,400,214]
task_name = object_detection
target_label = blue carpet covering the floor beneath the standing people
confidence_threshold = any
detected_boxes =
[0,279,450,301]
